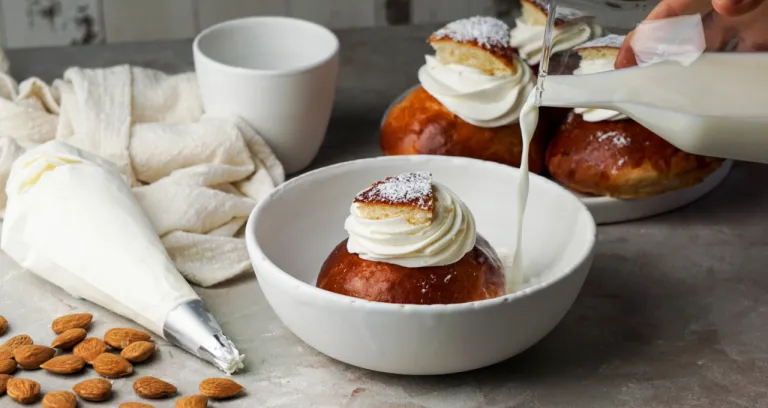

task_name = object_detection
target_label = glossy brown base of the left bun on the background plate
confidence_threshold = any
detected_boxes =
[381,86,546,173]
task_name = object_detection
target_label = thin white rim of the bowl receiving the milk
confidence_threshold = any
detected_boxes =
[245,155,597,313]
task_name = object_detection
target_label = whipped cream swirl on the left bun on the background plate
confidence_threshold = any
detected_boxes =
[419,55,534,128]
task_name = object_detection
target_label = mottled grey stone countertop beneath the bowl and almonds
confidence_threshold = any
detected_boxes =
[0,27,768,408]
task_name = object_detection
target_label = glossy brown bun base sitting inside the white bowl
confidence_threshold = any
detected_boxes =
[317,237,505,305]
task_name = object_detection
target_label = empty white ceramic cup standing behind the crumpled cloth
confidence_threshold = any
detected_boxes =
[193,17,339,173]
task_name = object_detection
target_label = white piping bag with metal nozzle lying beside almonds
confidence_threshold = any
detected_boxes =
[0,141,243,374]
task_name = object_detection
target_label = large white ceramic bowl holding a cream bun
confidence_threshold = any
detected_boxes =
[246,156,595,375]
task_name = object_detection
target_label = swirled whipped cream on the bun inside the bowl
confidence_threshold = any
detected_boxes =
[344,183,477,268]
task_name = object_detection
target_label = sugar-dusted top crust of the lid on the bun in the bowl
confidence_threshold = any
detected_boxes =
[355,171,434,211]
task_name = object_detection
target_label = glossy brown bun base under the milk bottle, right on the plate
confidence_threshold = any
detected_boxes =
[547,113,723,199]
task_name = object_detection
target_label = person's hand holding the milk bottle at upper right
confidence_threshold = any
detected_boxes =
[615,0,768,68]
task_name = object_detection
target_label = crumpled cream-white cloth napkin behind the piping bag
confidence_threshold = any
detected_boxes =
[0,52,285,286]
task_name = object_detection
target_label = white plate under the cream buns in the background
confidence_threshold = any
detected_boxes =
[381,85,733,225]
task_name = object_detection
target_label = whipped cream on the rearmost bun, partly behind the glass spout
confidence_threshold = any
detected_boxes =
[509,17,603,65]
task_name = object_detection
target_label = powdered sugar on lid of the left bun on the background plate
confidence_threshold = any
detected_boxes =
[434,16,509,49]
